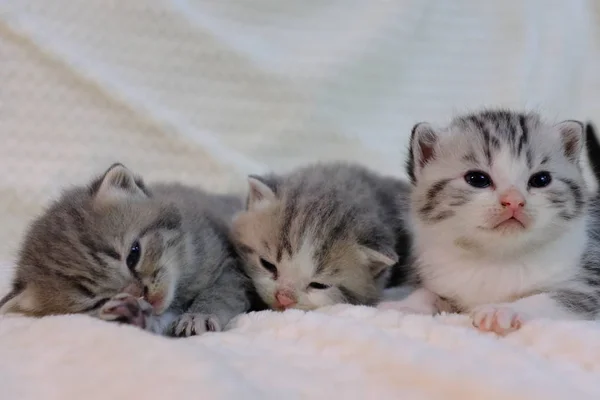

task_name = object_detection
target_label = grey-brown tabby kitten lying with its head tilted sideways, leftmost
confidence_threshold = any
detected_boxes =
[0,164,250,336]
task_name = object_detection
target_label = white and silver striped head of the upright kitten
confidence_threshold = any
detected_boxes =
[409,112,586,252]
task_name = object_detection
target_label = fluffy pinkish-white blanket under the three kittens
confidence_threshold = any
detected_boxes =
[0,270,600,400]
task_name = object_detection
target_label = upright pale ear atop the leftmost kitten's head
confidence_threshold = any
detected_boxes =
[92,164,148,202]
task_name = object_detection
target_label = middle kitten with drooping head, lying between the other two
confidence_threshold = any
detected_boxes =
[232,163,409,310]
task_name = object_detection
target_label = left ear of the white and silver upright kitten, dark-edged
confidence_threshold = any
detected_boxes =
[406,122,438,184]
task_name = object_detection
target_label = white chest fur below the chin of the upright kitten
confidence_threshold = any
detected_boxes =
[415,219,587,310]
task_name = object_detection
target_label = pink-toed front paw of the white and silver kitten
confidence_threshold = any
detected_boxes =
[471,304,527,335]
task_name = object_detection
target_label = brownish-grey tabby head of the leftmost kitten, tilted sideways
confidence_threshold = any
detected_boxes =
[2,165,184,316]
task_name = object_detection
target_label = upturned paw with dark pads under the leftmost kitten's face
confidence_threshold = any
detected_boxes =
[98,293,152,329]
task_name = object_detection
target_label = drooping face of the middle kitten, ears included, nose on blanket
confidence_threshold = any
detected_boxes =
[233,178,395,310]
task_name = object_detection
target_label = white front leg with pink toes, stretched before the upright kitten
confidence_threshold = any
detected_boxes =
[471,291,586,335]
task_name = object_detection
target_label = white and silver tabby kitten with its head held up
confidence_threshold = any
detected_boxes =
[382,110,600,334]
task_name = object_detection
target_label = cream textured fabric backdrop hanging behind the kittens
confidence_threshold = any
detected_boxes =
[0,0,600,260]
